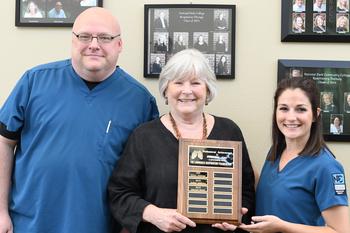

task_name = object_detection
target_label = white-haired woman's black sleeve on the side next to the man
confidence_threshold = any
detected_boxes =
[108,129,150,233]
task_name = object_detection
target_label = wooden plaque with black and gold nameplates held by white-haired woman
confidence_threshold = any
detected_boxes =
[177,139,242,225]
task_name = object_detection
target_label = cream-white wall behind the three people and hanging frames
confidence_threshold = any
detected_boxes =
[0,0,350,204]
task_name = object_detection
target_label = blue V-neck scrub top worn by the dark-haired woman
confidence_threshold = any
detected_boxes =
[256,149,348,226]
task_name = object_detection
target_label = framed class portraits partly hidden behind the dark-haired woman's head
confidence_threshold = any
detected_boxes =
[278,60,350,141]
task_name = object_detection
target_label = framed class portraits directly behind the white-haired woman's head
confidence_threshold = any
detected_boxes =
[143,4,236,79]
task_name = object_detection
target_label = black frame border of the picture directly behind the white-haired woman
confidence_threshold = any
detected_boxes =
[143,4,236,80]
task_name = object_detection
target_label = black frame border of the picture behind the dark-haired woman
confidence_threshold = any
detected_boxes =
[277,59,350,142]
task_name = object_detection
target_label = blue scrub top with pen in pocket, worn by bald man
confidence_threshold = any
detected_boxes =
[0,60,158,233]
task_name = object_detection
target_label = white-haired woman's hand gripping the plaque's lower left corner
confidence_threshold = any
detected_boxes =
[142,205,196,232]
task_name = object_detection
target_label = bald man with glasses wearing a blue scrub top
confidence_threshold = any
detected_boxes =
[0,7,158,233]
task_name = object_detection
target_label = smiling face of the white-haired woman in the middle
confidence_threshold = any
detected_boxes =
[165,76,207,116]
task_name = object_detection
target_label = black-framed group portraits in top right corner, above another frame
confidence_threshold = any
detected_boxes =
[281,0,350,42]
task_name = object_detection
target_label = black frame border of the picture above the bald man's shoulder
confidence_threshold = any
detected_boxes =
[15,0,103,27]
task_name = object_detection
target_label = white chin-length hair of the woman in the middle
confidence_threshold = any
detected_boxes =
[159,49,217,103]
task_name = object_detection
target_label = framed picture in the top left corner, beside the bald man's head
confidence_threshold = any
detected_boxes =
[15,0,102,27]
